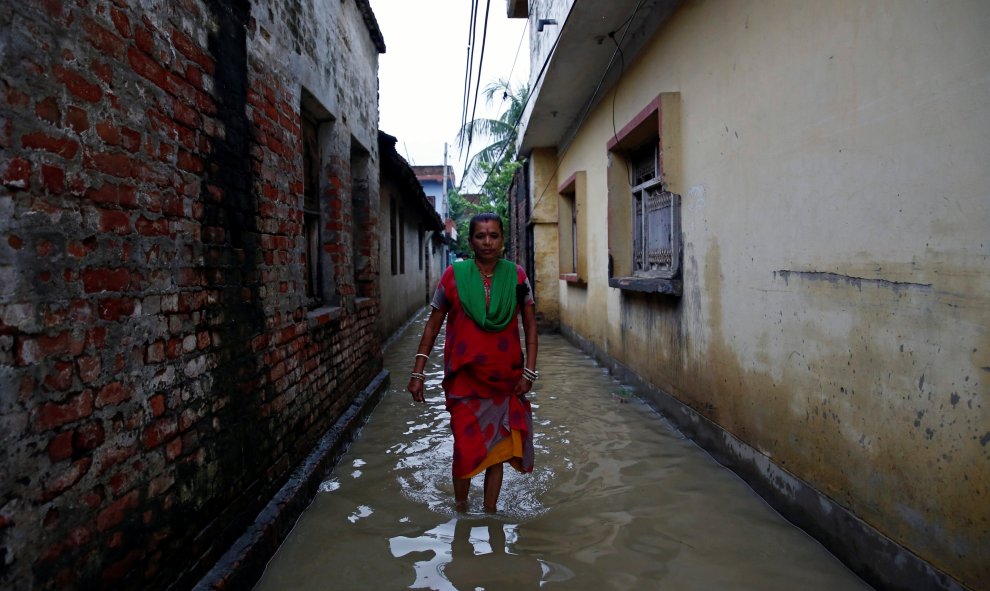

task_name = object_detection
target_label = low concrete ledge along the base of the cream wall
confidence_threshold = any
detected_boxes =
[561,326,968,591]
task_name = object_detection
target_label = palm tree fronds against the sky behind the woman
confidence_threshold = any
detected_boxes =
[457,79,529,184]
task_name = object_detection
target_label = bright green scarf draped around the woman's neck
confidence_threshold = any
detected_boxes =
[454,259,519,332]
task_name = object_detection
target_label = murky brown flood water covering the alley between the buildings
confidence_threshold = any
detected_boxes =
[256,314,870,591]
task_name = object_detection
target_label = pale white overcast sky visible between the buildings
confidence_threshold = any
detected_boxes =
[370,0,529,189]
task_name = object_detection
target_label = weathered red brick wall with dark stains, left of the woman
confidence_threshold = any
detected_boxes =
[0,0,384,589]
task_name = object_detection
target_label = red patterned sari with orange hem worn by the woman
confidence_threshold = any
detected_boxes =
[433,265,533,478]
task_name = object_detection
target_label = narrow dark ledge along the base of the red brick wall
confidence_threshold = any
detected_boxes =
[193,370,389,591]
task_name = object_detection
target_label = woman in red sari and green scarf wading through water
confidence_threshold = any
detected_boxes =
[408,213,539,513]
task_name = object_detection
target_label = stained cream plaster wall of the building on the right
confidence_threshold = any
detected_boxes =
[556,0,990,588]
